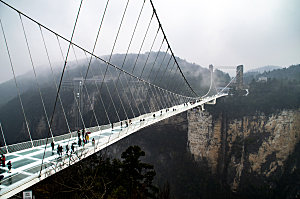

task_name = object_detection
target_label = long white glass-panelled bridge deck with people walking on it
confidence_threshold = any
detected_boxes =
[0,94,227,198]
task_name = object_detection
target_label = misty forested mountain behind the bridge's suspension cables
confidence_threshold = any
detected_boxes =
[0,53,229,144]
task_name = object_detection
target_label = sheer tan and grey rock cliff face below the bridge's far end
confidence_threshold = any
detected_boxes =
[188,109,300,191]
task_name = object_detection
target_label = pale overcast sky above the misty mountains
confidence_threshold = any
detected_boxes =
[0,0,300,82]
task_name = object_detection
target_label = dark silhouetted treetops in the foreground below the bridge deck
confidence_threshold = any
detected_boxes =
[32,146,158,199]
